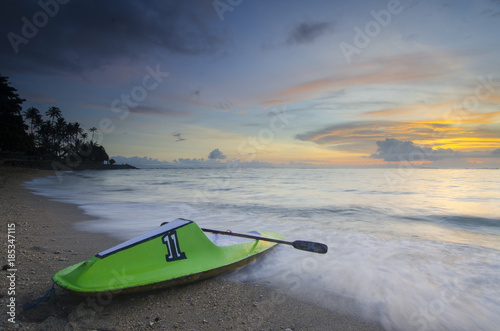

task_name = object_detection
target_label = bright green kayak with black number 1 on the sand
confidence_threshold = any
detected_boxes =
[52,218,283,295]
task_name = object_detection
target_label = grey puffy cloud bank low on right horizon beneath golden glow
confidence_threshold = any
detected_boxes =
[370,138,499,162]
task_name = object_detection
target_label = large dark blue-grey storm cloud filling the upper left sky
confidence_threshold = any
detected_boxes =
[0,0,225,73]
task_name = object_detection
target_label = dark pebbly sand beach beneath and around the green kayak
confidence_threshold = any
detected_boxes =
[0,166,383,330]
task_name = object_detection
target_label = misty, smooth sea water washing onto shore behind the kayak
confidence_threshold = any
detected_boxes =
[25,167,500,330]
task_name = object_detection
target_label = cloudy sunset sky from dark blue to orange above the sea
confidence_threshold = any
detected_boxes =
[0,0,500,166]
